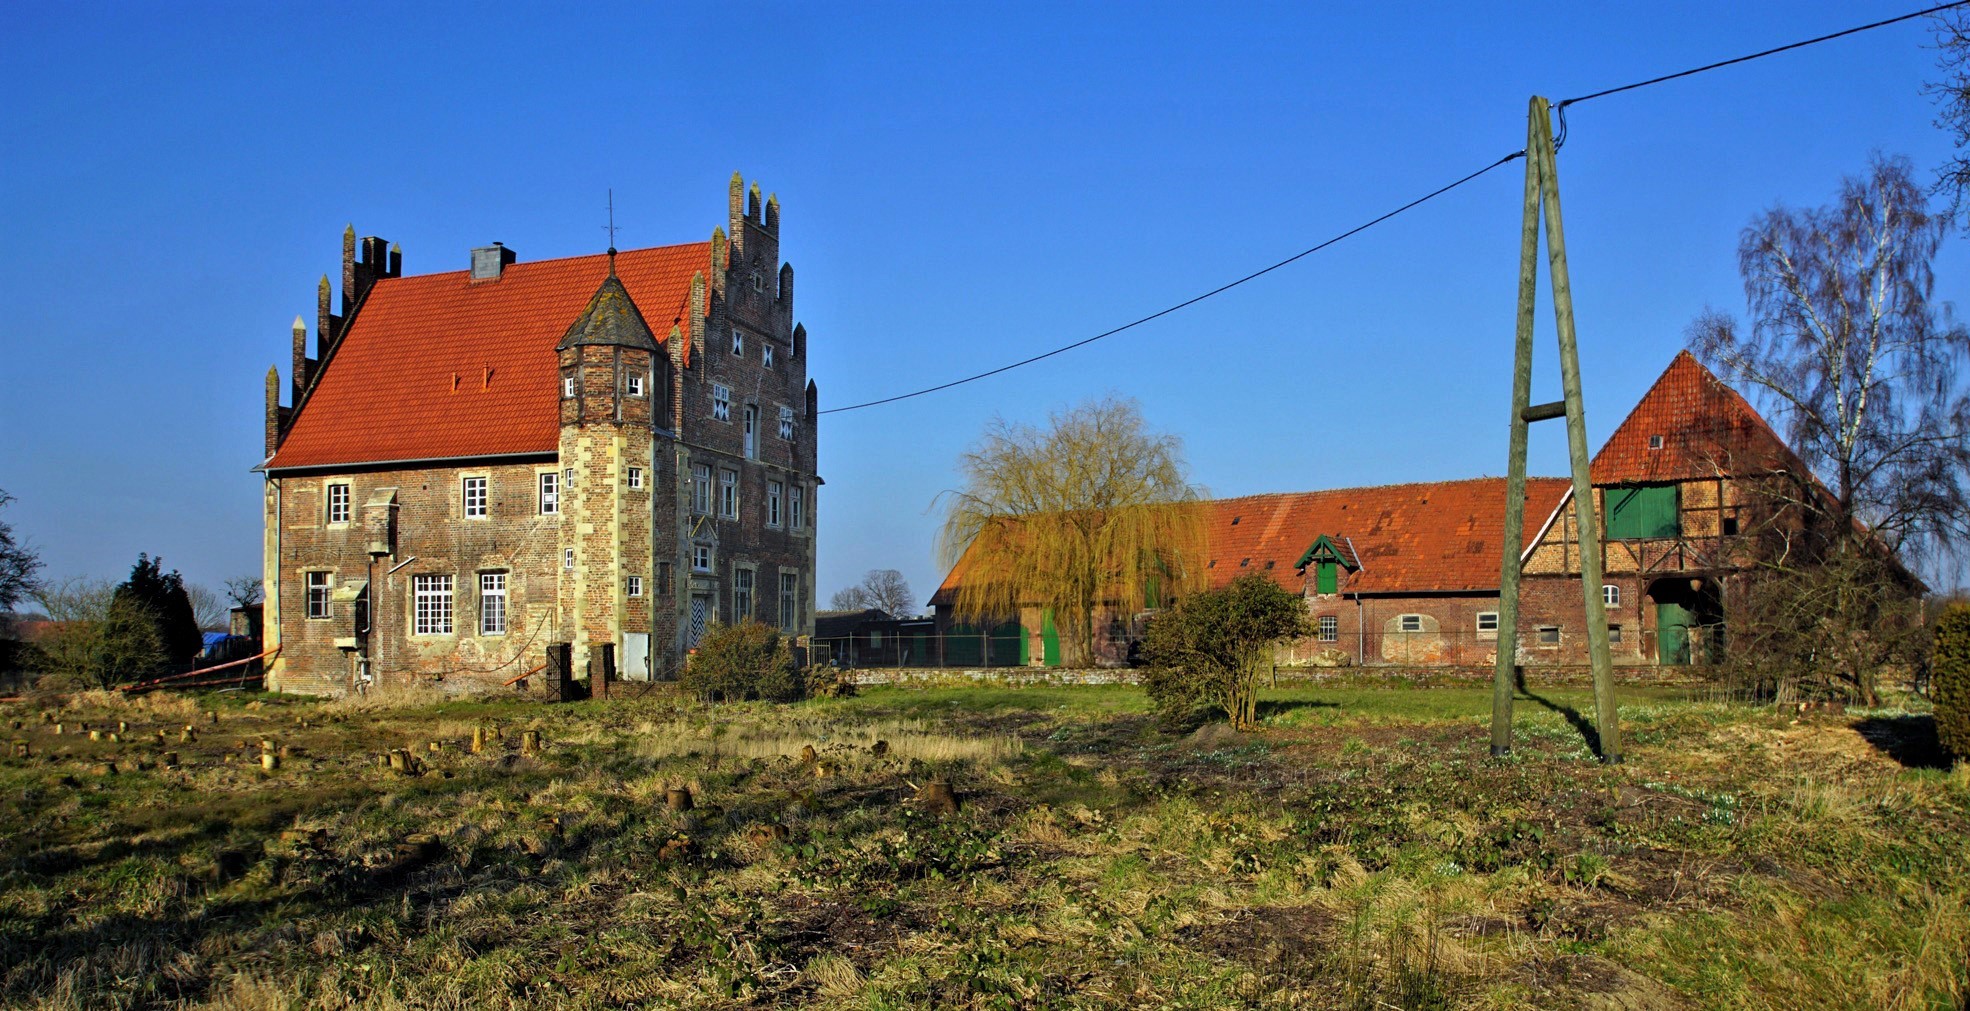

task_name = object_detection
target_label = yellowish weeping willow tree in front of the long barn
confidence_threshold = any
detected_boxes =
[938,398,1204,666]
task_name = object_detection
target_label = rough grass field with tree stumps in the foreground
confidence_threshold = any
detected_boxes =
[0,686,1970,1011]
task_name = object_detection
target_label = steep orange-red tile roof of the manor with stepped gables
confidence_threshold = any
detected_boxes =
[266,242,711,469]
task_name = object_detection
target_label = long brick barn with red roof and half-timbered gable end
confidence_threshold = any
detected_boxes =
[930,351,1851,666]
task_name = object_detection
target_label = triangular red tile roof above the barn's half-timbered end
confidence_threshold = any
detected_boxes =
[1588,351,1806,485]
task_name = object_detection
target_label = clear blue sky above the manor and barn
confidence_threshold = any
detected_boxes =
[0,0,1970,597]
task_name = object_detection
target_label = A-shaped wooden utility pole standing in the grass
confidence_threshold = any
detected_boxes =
[1491,95,1621,765]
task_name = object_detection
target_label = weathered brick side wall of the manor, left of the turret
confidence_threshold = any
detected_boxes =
[268,457,561,694]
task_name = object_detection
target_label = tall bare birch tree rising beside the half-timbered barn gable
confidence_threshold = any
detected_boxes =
[1690,158,1970,567]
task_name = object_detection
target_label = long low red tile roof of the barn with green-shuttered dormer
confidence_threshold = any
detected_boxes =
[930,477,1570,605]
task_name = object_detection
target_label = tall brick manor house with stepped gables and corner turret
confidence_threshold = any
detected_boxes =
[258,175,821,694]
